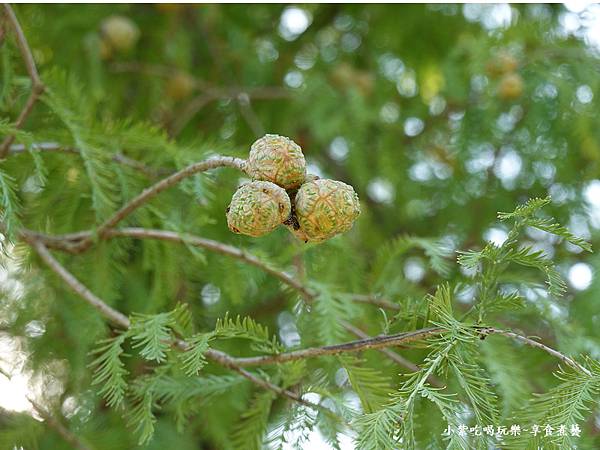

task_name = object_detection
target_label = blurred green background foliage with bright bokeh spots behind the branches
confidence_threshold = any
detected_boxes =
[0,4,600,449]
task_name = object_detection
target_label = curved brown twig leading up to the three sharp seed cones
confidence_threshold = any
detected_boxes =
[71,156,245,251]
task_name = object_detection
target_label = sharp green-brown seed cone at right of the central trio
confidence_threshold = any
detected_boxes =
[288,179,360,242]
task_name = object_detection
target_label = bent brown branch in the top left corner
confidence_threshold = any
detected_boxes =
[0,3,45,159]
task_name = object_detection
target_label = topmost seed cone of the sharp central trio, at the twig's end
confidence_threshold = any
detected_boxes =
[247,134,306,189]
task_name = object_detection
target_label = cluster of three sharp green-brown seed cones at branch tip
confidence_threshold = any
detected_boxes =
[227,134,360,242]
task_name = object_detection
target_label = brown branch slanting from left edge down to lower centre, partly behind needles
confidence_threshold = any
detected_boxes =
[28,238,331,414]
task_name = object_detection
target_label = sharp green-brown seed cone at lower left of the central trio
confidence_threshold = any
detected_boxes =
[227,181,291,237]
